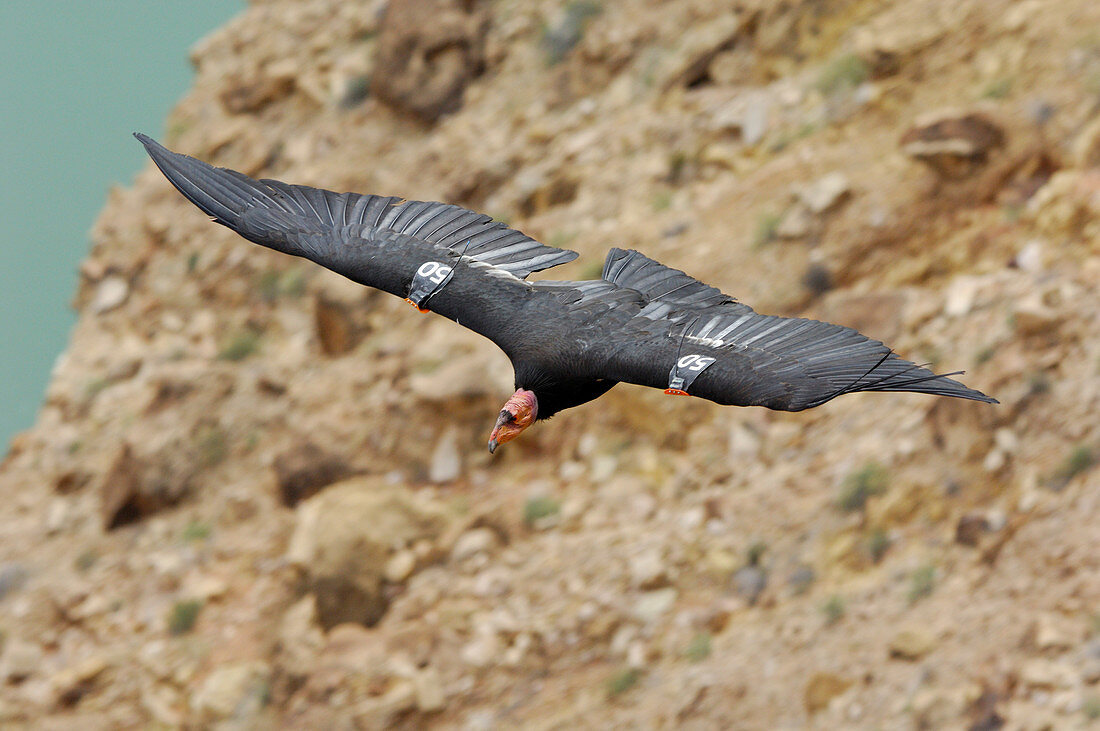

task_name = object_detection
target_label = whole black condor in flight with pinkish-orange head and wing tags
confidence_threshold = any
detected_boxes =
[135,134,997,452]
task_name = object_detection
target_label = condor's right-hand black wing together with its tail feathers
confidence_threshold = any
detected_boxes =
[593,250,997,411]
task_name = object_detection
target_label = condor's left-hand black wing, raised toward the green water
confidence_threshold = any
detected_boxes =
[134,134,576,355]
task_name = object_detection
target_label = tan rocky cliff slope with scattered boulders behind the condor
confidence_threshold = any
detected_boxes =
[0,0,1100,729]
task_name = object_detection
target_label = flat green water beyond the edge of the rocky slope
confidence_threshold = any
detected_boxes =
[0,0,244,456]
